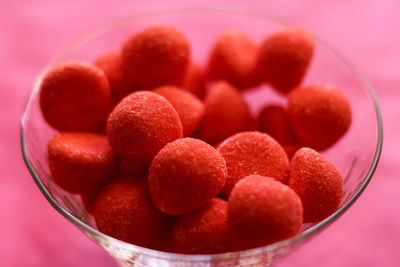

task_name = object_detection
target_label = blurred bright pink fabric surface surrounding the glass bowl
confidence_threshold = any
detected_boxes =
[0,0,400,267]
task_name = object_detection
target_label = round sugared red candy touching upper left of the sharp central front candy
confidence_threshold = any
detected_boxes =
[107,91,182,166]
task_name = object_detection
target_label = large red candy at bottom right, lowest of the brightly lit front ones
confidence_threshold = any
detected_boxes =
[228,175,303,249]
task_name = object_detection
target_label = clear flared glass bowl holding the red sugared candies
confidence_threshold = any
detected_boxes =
[21,8,382,266]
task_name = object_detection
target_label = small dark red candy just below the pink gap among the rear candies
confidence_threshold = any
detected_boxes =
[257,105,297,146]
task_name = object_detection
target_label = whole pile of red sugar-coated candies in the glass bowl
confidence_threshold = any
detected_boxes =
[40,26,351,254]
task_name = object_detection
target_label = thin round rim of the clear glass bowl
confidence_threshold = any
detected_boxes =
[20,7,383,262]
